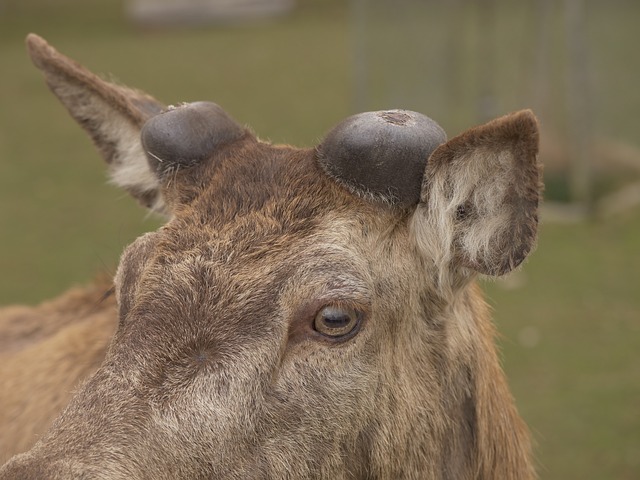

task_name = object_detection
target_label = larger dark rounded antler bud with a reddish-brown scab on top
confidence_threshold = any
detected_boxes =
[317,110,447,208]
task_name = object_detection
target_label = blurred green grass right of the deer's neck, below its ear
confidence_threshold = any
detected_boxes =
[486,215,640,479]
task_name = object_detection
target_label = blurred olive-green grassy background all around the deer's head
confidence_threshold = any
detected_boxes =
[0,0,640,480]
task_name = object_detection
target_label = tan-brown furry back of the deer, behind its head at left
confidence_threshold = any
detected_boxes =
[0,278,117,463]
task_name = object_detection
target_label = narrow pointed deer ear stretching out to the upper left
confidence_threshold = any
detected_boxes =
[27,34,164,212]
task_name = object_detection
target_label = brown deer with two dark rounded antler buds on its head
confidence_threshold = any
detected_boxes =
[0,34,542,480]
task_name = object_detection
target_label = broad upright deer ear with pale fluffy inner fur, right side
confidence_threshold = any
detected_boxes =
[413,110,541,275]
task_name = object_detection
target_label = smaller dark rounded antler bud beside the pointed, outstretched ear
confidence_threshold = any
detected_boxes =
[141,102,247,178]
